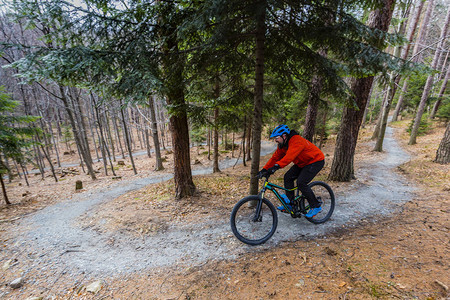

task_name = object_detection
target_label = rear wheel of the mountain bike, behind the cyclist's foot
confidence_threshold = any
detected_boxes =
[300,181,335,224]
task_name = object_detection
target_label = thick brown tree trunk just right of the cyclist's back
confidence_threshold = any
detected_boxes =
[328,0,395,181]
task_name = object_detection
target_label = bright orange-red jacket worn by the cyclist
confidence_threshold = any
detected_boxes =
[264,134,325,170]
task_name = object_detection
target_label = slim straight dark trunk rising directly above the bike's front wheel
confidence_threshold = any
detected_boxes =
[250,0,267,195]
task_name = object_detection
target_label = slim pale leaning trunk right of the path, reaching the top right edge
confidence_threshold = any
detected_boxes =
[408,4,450,145]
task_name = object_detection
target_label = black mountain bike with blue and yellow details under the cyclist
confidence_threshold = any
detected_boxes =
[230,175,335,246]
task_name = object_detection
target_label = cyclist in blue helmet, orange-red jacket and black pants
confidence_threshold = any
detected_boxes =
[258,125,325,218]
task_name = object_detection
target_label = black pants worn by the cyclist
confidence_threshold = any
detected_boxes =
[284,160,325,208]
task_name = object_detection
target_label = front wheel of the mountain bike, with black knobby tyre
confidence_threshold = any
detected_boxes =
[230,195,278,246]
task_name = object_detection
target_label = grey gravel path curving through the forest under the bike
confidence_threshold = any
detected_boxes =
[11,124,412,282]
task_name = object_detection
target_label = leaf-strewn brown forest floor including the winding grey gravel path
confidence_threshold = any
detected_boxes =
[0,121,450,299]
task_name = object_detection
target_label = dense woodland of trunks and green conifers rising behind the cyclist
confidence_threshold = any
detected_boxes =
[0,0,450,203]
